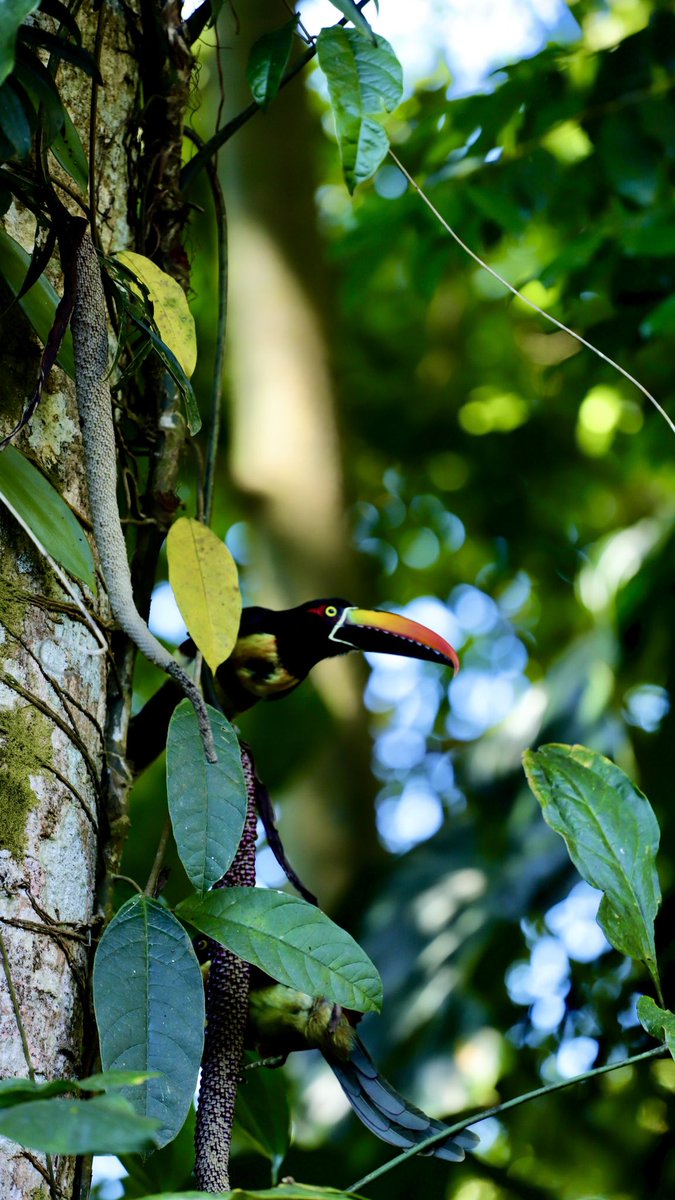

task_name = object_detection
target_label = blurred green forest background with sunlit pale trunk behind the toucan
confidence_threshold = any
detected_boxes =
[115,0,675,1200]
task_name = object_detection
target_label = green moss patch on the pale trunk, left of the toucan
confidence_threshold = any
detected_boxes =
[0,704,52,859]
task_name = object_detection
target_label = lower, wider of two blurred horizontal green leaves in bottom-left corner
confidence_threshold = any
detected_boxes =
[0,1096,159,1154]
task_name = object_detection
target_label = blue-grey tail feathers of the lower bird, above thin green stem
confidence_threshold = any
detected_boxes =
[327,1038,479,1163]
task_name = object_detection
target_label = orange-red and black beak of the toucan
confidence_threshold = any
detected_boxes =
[329,608,459,674]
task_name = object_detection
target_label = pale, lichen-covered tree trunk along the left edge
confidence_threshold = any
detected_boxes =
[0,4,137,1200]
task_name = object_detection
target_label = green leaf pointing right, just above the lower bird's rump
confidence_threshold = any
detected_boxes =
[177,888,382,1013]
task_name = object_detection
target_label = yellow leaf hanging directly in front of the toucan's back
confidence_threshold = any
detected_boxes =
[167,517,241,671]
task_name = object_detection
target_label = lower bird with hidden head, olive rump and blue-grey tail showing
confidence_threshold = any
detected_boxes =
[193,936,478,1163]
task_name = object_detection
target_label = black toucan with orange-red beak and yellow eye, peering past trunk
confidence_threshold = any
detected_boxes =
[127,598,459,772]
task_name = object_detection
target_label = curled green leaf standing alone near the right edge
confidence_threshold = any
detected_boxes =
[522,744,661,980]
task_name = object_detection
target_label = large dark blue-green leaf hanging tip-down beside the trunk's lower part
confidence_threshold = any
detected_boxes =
[94,896,204,1146]
